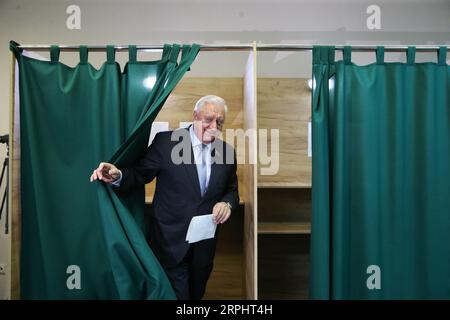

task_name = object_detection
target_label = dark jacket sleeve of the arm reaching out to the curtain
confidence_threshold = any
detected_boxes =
[114,133,162,193]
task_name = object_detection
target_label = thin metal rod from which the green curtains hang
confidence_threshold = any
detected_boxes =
[18,44,450,52]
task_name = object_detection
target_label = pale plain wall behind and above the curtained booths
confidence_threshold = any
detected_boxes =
[0,0,450,298]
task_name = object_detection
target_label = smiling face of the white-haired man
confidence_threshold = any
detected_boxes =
[194,103,225,143]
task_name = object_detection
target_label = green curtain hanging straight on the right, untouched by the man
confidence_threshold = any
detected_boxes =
[310,46,450,299]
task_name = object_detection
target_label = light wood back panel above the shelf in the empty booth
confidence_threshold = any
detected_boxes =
[257,78,311,187]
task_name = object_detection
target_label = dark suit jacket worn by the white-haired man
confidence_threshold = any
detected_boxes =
[117,129,239,267]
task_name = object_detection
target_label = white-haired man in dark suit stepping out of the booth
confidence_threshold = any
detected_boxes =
[91,95,239,300]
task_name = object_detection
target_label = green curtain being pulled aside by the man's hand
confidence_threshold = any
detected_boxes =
[10,42,199,299]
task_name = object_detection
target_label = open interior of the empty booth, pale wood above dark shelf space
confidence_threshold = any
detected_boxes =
[257,78,311,299]
